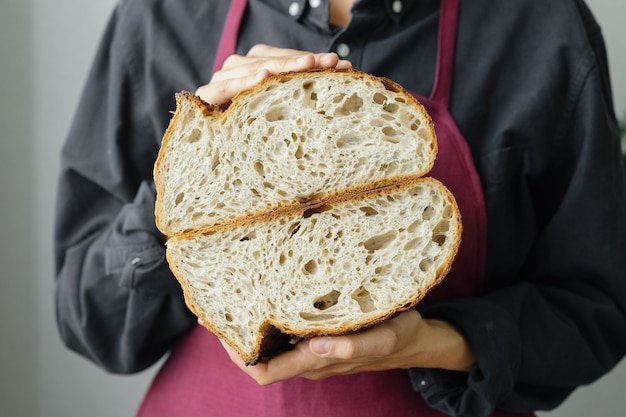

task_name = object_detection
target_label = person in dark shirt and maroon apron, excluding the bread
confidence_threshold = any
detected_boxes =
[55,0,626,417]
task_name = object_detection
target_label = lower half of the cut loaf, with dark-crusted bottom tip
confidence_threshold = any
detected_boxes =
[167,178,461,364]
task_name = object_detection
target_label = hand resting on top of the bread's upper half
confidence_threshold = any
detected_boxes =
[196,44,352,107]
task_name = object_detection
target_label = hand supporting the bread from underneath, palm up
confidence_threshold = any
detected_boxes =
[222,310,475,385]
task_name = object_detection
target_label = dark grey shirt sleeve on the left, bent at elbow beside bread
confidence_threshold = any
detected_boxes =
[55,6,195,373]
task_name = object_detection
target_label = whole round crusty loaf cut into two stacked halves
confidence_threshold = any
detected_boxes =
[154,70,462,364]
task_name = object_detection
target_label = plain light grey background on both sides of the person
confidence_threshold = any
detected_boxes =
[0,0,626,417]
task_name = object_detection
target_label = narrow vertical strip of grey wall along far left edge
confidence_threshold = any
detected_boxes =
[0,0,41,416]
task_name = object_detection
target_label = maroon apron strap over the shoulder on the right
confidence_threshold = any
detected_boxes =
[430,0,459,109]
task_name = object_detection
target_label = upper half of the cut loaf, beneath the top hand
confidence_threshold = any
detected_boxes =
[154,70,437,236]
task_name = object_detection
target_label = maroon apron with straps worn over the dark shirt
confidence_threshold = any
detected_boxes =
[137,0,532,417]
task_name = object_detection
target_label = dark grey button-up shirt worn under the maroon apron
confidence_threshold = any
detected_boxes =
[55,0,626,417]
